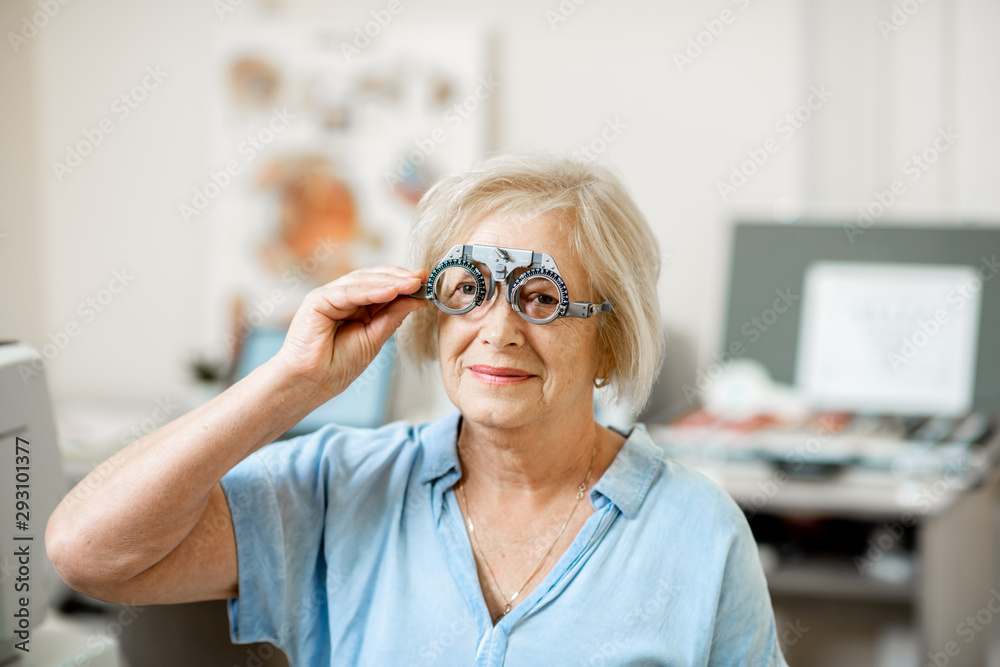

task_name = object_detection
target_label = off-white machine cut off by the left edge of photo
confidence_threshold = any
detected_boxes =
[0,341,66,666]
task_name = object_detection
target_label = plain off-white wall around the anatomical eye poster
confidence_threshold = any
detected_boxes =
[0,0,1000,422]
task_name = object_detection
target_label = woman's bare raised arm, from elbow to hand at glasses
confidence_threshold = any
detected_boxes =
[45,267,427,604]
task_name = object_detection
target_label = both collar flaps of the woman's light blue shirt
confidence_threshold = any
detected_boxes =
[410,410,663,519]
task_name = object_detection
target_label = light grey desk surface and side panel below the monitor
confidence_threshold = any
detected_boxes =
[650,428,1000,667]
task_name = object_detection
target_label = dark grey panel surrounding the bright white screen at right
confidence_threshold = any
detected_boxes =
[720,221,1000,414]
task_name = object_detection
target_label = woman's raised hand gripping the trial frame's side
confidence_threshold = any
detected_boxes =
[274,266,428,402]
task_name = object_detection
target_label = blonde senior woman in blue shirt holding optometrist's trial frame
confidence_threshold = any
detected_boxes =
[46,156,785,666]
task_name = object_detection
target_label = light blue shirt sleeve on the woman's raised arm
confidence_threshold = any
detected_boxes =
[221,427,329,648]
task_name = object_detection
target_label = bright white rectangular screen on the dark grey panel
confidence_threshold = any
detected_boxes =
[795,261,982,414]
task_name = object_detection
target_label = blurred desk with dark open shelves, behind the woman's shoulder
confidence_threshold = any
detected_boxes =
[651,433,1000,667]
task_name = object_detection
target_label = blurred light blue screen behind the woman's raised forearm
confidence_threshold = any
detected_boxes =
[236,328,397,437]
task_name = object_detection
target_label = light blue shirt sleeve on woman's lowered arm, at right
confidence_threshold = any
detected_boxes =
[708,514,788,667]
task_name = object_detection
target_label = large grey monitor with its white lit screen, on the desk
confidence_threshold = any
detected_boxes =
[720,221,1000,414]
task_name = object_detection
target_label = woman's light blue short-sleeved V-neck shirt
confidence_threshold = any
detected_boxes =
[222,410,786,667]
